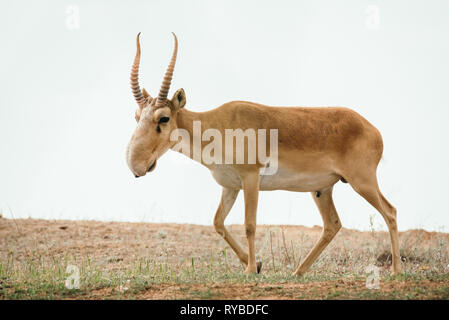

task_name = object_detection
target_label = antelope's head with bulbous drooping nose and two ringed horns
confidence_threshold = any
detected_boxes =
[126,33,186,178]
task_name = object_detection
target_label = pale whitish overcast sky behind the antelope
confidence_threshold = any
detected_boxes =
[0,0,449,232]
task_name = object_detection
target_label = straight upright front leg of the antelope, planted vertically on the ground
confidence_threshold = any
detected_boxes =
[242,172,259,274]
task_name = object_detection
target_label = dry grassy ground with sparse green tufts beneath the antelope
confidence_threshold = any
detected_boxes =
[0,219,449,299]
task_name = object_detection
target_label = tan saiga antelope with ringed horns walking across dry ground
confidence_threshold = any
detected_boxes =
[126,33,401,275]
